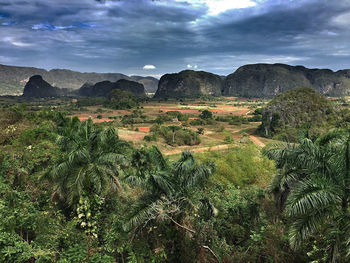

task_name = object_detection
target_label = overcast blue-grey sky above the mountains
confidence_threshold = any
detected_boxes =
[0,0,350,77]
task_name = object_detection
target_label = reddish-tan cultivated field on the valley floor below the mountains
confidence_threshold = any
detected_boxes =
[67,98,269,155]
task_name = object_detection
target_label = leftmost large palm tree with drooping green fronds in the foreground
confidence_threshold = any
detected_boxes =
[51,118,127,205]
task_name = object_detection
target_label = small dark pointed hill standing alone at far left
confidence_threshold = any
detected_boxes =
[23,75,65,98]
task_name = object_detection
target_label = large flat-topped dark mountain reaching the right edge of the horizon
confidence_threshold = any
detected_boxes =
[223,64,350,97]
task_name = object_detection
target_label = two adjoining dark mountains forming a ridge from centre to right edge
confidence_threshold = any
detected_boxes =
[155,64,350,98]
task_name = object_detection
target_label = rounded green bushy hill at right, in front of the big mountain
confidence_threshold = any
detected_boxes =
[259,88,337,140]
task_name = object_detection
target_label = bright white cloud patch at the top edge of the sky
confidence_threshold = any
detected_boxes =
[175,0,256,16]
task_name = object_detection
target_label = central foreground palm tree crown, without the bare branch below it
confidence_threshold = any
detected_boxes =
[124,151,214,233]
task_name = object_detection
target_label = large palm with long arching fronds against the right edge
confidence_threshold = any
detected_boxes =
[267,130,350,262]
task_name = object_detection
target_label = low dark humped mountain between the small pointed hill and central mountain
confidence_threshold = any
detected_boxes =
[78,79,146,97]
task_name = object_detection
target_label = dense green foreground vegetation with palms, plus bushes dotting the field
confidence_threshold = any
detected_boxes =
[0,100,350,263]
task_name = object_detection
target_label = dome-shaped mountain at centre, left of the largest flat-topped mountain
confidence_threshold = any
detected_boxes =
[154,70,223,98]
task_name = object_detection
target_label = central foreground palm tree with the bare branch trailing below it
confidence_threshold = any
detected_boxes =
[125,151,218,261]
